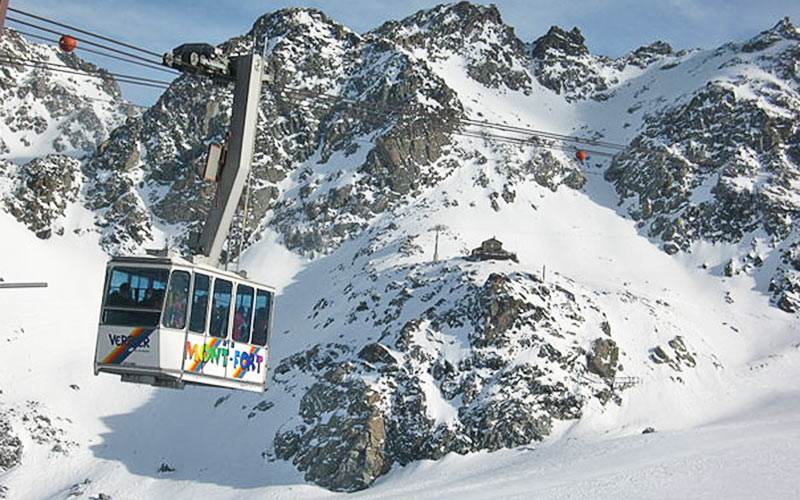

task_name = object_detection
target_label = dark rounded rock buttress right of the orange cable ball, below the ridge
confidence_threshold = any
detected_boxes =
[606,86,797,245]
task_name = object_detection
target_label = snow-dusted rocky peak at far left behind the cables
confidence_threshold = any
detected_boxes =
[0,29,132,249]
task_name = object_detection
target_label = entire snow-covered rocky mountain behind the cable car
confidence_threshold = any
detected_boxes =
[0,2,800,497]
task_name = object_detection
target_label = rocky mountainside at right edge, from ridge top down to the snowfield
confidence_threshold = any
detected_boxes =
[605,20,800,310]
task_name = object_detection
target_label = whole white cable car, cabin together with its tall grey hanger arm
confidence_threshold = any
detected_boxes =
[94,54,275,392]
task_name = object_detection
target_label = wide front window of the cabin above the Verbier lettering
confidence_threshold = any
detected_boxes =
[102,267,169,326]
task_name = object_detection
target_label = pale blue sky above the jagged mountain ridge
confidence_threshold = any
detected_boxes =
[7,0,800,105]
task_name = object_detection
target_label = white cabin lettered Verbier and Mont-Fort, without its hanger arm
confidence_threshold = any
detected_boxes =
[94,256,275,392]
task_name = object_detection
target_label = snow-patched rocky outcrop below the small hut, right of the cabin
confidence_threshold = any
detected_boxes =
[274,264,620,491]
